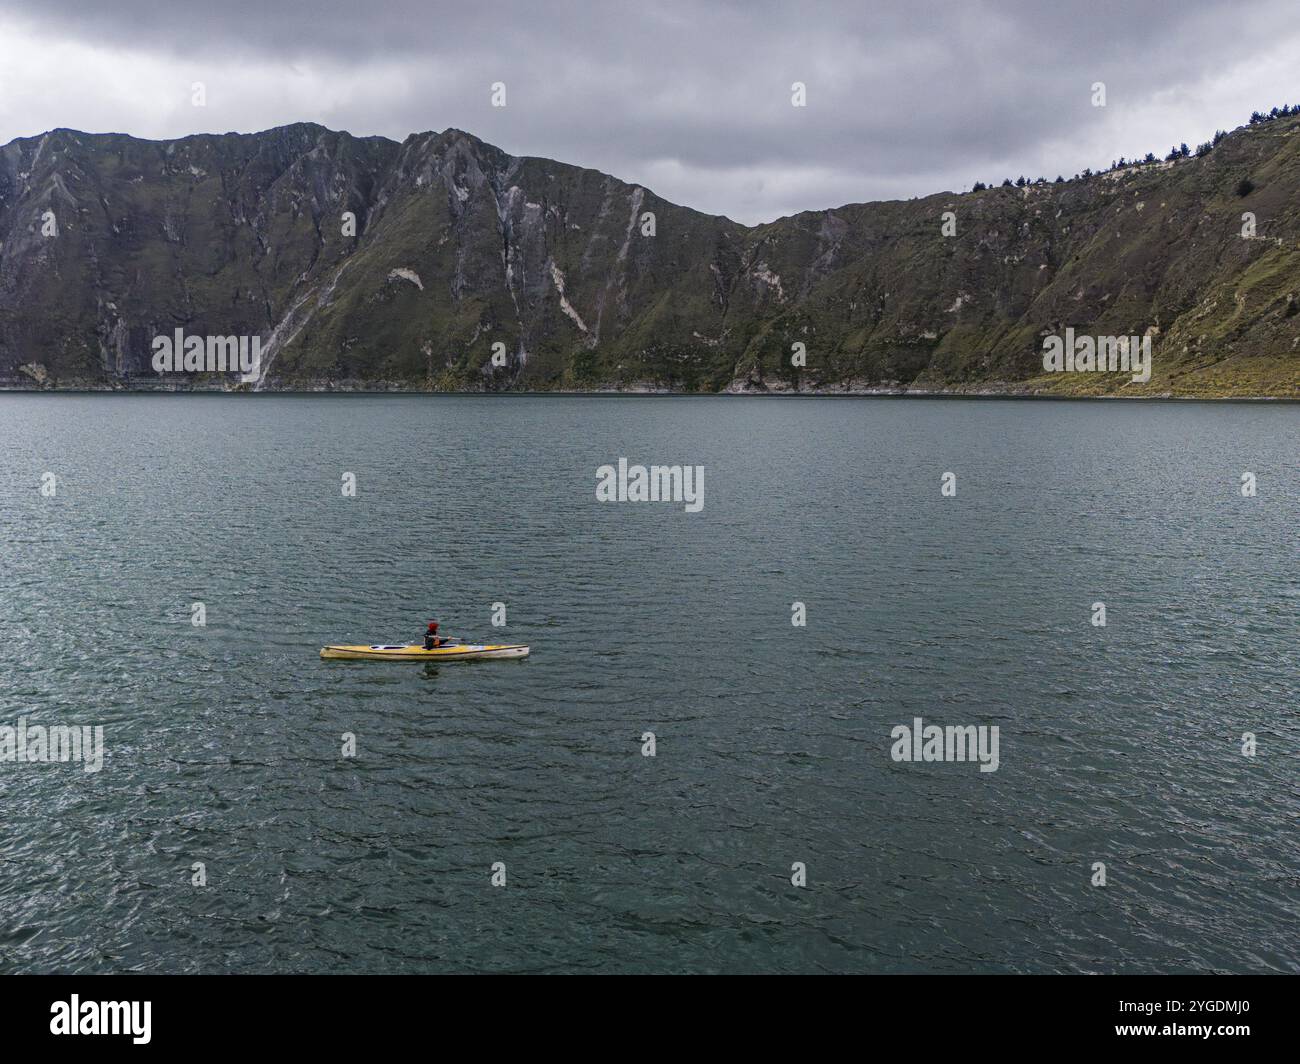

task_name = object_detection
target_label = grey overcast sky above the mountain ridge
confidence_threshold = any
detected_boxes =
[0,0,1300,222]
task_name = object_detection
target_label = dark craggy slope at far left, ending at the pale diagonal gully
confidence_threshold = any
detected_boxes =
[0,126,394,385]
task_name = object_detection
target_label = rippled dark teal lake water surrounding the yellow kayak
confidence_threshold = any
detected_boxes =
[0,395,1300,972]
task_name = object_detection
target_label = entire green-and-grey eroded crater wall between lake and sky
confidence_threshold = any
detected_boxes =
[0,118,1300,395]
